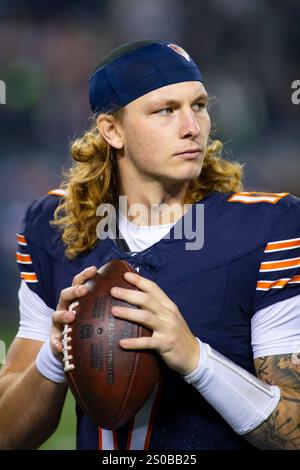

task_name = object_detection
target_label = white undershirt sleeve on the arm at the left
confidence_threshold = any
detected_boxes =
[17,281,54,341]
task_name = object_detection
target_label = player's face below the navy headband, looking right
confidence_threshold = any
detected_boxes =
[119,81,210,187]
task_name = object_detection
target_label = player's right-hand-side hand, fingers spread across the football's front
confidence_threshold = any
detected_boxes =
[111,272,199,375]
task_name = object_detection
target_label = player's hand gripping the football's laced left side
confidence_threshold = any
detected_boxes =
[51,266,97,359]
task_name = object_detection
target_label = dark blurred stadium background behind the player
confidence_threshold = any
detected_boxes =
[0,0,300,449]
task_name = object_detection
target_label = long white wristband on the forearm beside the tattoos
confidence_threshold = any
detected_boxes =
[183,338,280,434]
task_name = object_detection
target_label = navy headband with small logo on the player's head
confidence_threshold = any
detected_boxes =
[89,41,203,113]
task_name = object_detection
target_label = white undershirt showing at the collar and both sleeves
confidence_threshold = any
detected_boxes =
[17,218,300,358]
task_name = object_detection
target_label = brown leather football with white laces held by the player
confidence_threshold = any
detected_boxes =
[63,260,159,429]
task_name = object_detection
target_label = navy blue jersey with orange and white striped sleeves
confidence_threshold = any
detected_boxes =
[17,192,300,450]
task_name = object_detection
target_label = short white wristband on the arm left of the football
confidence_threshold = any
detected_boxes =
[35,338,66,383]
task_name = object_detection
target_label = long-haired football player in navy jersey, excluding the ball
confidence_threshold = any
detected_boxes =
[0,41,300,450]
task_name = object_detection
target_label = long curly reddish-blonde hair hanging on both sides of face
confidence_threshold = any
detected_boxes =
[51,110,243,259]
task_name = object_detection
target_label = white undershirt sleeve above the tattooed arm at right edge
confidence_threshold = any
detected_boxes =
[251,295,300,359]
